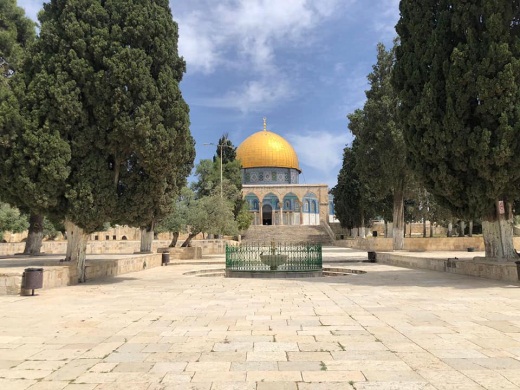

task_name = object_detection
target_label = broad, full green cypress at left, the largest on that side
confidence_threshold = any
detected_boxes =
[24,0,194,281]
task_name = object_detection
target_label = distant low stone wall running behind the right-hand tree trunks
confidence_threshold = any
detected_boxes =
[335,236,520,252]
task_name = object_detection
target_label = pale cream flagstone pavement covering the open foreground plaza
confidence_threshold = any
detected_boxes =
[0,248,520,390]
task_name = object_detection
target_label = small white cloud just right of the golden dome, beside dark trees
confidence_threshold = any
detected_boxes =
[287,131,350,180]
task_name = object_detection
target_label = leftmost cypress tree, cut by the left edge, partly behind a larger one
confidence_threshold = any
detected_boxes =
[0,0,62,254]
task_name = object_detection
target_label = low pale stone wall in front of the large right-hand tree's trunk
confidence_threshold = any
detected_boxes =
[377,253,519,282]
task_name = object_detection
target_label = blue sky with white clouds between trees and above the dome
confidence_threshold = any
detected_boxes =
[18,0,399,187]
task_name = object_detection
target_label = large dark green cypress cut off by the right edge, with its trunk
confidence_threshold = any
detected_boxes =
[394,0,520,258]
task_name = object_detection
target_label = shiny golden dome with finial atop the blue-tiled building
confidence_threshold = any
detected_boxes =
[237,128,301,172]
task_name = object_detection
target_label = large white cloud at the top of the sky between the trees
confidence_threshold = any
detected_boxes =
[174,0,350,73]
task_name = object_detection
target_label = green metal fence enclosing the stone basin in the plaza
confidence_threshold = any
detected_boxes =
[226,242,322,271]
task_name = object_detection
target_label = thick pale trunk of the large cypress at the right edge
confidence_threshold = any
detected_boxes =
[482,201,518,259]
